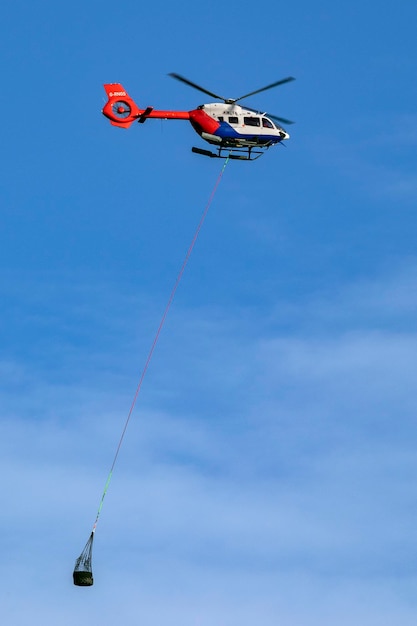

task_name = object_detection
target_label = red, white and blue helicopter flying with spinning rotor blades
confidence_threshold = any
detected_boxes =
[102,73,295,161]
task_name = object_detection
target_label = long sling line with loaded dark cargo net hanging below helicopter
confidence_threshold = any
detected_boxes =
[73,151,228,587]
